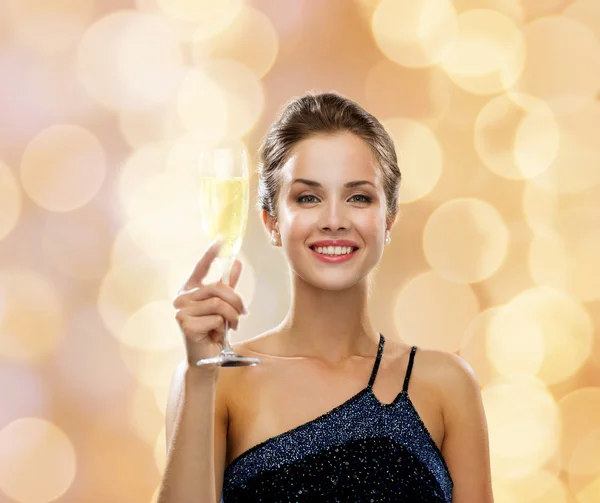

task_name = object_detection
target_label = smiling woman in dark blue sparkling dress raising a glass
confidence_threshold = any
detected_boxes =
[159,93,492,503]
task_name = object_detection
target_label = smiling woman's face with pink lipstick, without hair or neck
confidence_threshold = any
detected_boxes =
[270,132,386,290]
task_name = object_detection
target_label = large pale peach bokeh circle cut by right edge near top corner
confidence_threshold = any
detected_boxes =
[514,16,600,112]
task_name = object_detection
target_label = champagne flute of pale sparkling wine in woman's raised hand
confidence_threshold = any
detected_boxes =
[196,145,260,367]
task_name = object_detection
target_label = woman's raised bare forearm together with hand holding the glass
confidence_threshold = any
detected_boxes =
[158,239,246,503]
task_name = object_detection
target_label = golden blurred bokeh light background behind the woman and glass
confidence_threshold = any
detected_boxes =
[0,0,600,503]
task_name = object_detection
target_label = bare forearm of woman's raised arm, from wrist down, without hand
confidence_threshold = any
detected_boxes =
[158,361,227,503]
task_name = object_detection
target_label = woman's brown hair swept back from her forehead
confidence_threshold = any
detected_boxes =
[257,92,401,222]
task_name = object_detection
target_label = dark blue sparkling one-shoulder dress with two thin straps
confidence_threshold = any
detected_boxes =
[221,334,453,503]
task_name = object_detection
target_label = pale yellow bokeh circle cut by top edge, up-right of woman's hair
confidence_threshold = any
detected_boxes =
[371,0,458,67]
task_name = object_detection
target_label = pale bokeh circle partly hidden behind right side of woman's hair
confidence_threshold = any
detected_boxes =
[383,118,442,203]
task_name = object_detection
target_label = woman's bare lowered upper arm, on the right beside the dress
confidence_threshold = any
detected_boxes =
[442,353,494,503]
